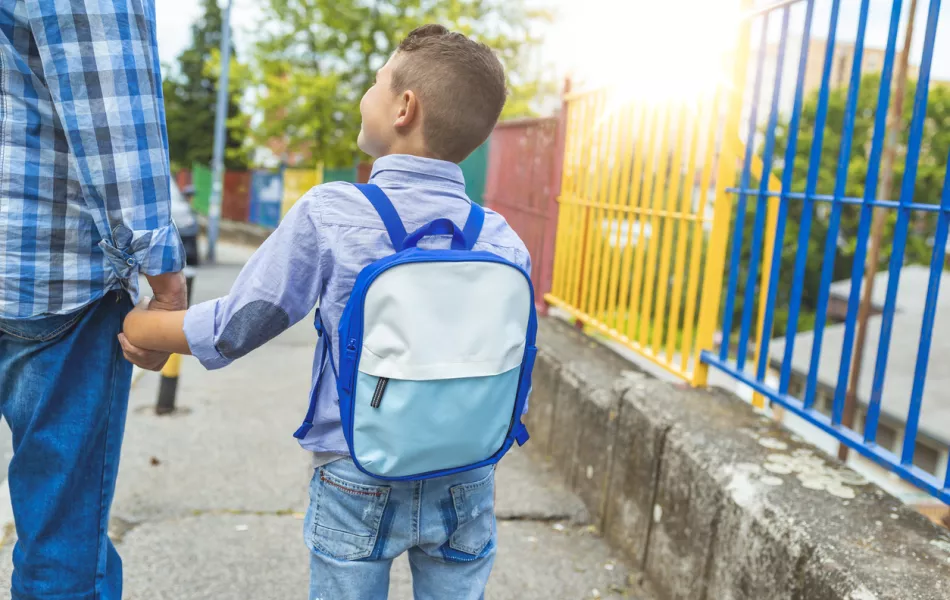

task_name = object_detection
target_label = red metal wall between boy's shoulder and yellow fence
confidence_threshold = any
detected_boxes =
[485,117,563,312]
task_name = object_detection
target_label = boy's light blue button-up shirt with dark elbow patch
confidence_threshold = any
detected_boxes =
[185,155,531,454]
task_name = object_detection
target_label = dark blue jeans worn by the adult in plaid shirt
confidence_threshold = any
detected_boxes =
[0,293,132,600]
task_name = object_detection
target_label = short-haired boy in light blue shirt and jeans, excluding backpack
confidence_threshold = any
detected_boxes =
[120,25,530,600]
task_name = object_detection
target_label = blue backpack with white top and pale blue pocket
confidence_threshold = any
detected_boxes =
[294,184,537,481]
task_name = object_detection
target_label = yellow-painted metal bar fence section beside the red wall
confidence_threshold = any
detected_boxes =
[545,82,779,385]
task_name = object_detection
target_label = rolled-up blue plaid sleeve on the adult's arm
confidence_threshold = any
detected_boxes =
[26,0,184,282]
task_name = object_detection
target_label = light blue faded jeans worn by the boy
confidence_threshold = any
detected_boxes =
[304,459,496,600]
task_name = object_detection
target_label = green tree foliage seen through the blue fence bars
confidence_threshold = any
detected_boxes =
[733,74,950,337]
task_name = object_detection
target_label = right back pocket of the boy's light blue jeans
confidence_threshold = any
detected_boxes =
[449,470,495,556]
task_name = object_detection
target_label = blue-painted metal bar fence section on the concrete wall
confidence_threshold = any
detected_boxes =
[702,0,950,501]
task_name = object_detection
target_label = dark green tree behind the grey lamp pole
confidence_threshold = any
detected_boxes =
[163,0,248,169]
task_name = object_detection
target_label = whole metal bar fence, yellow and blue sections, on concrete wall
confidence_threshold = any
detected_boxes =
[545,0,950,501]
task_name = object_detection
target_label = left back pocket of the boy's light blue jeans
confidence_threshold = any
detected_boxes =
[310,468,390,560]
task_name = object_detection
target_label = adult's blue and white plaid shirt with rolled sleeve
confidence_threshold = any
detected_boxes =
[0,0,184,319]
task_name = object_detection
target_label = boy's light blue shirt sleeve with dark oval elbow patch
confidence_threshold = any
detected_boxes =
[185,188,330,369]
